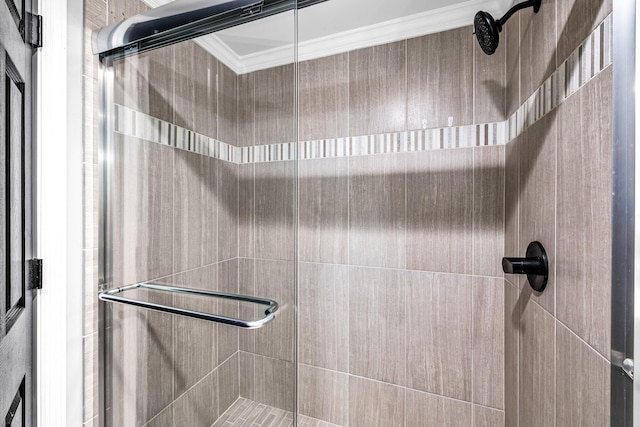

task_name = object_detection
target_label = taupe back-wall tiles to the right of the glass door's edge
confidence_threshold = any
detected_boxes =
[288,27,506,427]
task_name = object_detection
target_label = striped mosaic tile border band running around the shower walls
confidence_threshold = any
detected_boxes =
[115,15,613,164]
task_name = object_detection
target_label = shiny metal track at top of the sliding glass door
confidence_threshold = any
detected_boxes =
[93,0,327,58]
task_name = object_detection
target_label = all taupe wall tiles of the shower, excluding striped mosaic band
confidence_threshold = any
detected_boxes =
[84,0,611,427]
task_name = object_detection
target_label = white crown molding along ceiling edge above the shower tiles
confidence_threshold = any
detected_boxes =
[144,0,508,74]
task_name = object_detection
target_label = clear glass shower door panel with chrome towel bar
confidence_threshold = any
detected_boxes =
[100,2,297,427]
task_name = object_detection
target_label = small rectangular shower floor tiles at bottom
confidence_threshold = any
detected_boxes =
[211,397,340,427]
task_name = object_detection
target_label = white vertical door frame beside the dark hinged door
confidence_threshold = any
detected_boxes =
[33,0,84,427]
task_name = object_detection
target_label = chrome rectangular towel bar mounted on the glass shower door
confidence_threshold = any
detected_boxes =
[98,283,278,329]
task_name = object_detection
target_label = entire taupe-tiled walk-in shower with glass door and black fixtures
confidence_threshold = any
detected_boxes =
[89,0,621,427]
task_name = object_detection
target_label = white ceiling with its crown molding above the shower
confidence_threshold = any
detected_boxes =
[144,0,514,74]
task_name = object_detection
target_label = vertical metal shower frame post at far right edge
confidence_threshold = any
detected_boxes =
[610,0,640,426]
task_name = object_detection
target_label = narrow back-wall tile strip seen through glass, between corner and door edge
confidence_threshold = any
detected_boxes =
[237,61,296,411]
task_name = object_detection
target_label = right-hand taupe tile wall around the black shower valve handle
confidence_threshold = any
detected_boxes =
[504,0,612,427]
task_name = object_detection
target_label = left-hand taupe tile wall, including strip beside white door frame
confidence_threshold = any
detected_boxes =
[84,0,244,426]
